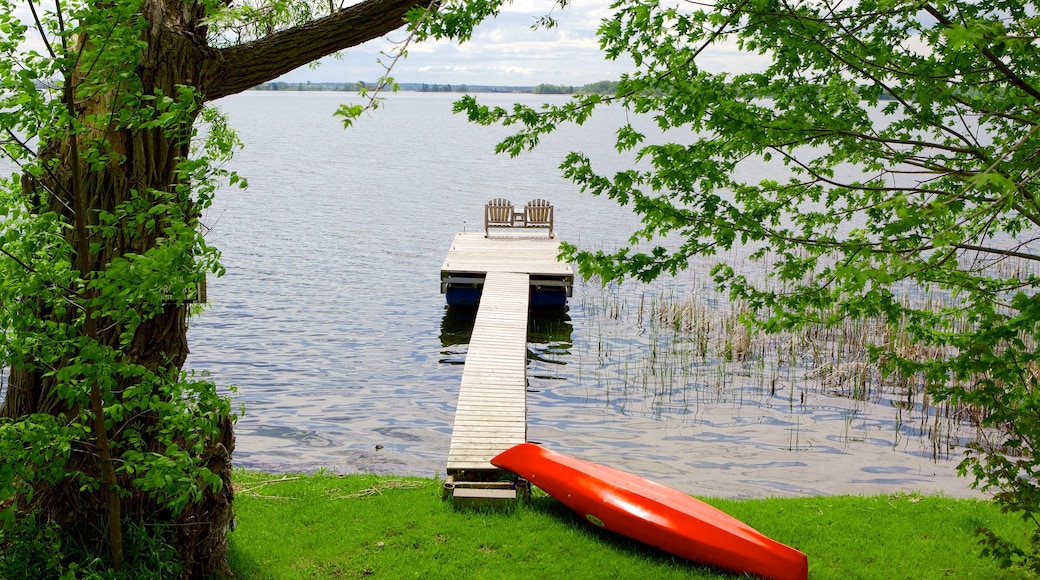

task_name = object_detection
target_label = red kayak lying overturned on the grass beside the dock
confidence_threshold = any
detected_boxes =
[491,443,809,580]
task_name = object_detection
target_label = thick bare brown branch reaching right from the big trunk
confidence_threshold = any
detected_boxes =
[200,0,426,101]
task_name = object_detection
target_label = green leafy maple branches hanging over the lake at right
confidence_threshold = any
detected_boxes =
[457,0,1040,571]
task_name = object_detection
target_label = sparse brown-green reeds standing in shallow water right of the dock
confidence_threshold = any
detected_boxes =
[579,270,1010,458]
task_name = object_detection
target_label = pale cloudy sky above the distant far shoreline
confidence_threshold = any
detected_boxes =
[279,0,769,86]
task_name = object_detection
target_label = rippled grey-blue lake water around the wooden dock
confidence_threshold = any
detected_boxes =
[2,91,971,497]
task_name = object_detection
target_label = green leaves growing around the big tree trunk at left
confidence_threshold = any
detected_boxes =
[0,1,240,577]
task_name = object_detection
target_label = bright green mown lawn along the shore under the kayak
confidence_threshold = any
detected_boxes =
[229,471,1030,580]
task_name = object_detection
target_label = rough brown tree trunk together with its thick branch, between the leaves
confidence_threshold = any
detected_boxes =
[0,0,416,577]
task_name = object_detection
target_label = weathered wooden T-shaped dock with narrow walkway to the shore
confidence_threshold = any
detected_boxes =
[441,233,574,505]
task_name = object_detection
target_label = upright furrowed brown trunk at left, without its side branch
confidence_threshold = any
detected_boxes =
[2,19,234,577]
